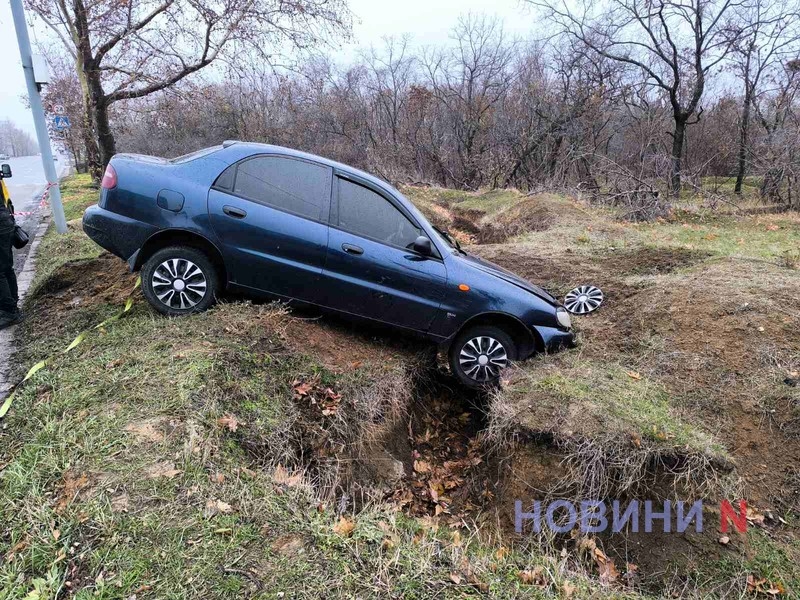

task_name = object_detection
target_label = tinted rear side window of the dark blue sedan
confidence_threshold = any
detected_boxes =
[233,156,331,220]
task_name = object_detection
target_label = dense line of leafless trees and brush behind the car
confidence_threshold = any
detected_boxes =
[29,0,800,204]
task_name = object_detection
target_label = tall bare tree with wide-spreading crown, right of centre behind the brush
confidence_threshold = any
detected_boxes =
[527,0,742,196]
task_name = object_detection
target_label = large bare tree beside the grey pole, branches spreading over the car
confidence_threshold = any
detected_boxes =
[28,0,350,177]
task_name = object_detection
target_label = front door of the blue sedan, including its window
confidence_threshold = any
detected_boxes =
[323,177,447,331]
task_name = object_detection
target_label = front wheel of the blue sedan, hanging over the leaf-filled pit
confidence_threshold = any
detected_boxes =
[449,325,517,388]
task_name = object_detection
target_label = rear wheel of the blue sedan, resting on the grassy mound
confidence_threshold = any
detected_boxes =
[142,246,219,317]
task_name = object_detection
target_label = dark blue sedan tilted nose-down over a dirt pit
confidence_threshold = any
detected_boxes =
[83,142,574,386]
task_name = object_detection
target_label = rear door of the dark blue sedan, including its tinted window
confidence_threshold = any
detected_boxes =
[208,155,332,303]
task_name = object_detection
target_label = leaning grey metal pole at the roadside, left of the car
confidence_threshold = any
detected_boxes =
[11,0,67,233]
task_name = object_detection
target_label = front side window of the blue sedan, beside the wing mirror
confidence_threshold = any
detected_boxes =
[338,179,420,248]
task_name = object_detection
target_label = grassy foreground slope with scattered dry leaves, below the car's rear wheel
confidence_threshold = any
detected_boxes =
[0,180,624,600]
